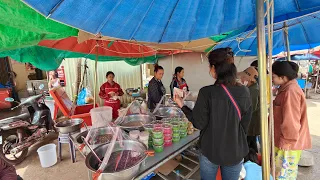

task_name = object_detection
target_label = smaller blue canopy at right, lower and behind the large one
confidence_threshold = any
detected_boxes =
[215,10,320,56]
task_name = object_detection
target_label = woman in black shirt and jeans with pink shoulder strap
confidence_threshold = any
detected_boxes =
[174,48,252,180]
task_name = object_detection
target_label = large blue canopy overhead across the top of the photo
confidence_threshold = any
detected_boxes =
[24,0,320,43]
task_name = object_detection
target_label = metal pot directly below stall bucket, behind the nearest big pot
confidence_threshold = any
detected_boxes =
[74,127,128,155]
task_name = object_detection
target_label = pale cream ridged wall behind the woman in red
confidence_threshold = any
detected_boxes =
[61,58,141,105]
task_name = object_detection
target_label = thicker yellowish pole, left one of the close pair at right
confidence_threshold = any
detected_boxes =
[256,0,270,180]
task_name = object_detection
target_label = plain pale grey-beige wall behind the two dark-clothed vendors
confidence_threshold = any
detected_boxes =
[159,53,256,93]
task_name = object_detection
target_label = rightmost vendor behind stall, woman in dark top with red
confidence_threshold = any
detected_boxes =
[170,66,189,98]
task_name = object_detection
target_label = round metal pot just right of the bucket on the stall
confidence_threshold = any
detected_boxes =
[118,114,156,130]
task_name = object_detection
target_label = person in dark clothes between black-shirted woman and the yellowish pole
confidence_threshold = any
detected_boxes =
[238,67,261,153]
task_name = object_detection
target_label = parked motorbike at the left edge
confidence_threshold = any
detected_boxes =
[0,86,56,165]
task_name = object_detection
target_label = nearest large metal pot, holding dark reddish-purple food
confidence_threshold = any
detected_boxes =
[85,140,147,180]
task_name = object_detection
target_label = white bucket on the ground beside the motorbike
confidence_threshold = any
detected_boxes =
[37,144,57,168]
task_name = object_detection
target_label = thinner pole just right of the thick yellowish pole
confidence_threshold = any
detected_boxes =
[267,0,276,177]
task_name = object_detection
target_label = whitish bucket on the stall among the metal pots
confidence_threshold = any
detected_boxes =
[90,106,112,128]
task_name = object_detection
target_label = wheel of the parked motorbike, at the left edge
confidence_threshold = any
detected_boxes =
[0,133,28,165]
